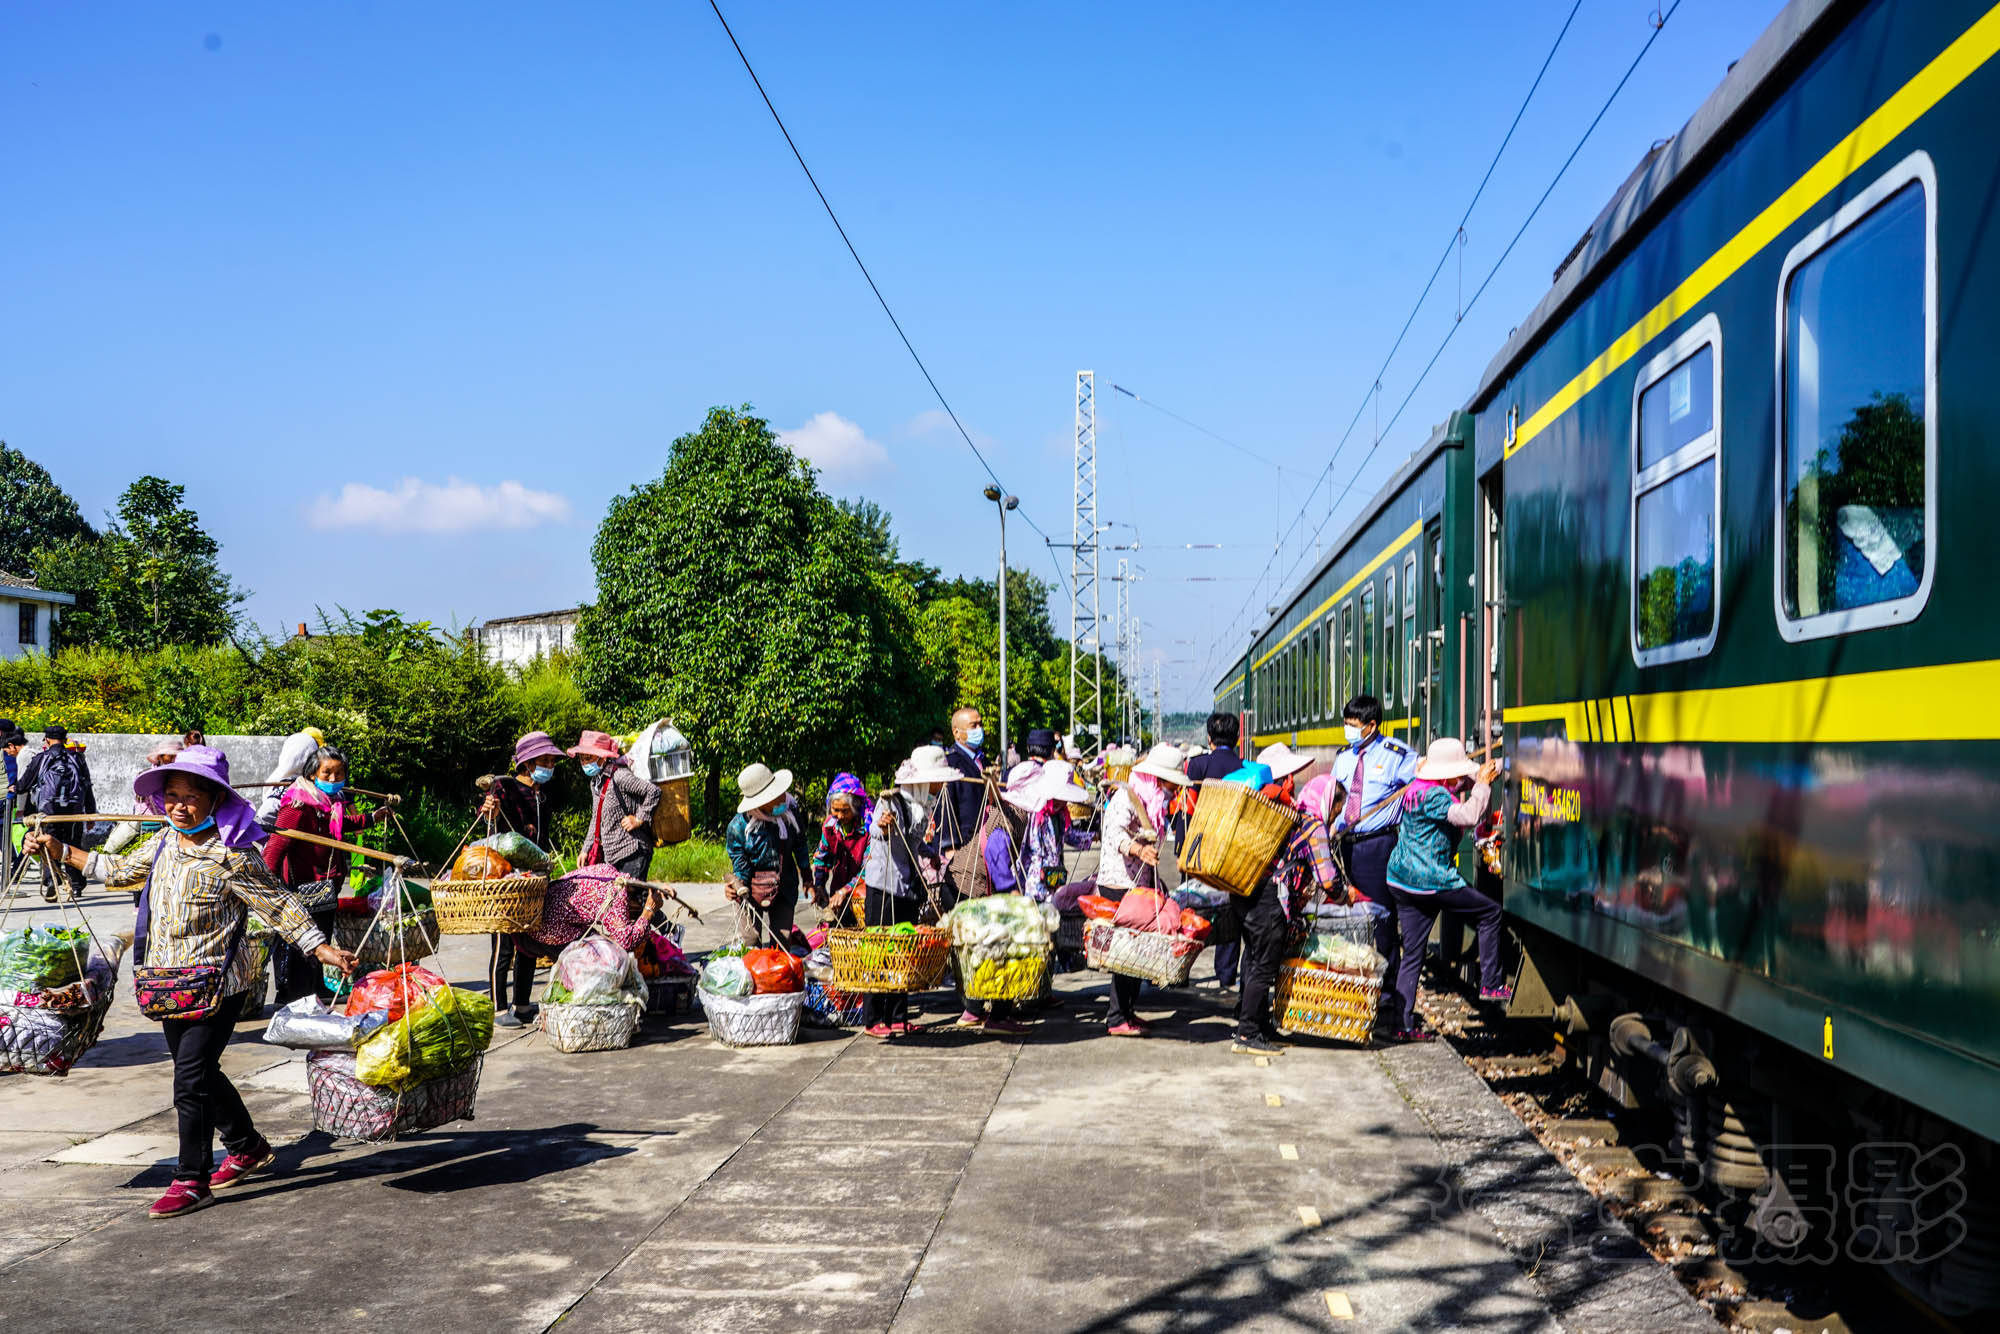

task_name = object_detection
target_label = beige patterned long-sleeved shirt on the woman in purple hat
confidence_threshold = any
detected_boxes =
[94,830,326,996]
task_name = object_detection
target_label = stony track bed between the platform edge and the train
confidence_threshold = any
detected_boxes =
[1418,988,1976,1334]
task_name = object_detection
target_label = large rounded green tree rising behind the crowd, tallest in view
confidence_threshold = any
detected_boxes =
[578,408,942,820]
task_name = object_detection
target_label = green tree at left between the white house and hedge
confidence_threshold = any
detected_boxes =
[34,476,248,652]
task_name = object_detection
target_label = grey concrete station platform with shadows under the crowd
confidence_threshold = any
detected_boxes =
[0,886,1712,1334]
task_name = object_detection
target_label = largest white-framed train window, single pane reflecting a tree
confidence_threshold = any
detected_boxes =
[1776,152,1938,640]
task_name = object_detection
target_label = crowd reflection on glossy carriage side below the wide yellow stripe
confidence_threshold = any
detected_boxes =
[1508,724,2000,1056]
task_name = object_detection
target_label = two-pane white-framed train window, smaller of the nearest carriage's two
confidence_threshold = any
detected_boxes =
[1632,316,1722,666]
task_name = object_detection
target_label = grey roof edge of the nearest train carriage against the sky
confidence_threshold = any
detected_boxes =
[1470,0,1850,410]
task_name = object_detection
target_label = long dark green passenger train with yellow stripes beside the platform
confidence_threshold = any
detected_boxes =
[1216,0,2000,1312]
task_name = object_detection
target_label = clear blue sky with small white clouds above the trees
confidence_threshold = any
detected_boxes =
[0,0,1782,708]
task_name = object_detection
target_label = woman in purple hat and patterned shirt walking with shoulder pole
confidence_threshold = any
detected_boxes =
[26,746,354,1218]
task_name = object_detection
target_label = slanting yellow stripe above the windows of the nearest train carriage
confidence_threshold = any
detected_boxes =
[1506,4,2000,458]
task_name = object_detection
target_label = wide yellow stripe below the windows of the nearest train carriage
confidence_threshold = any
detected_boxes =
[1504,660,2000,744]
